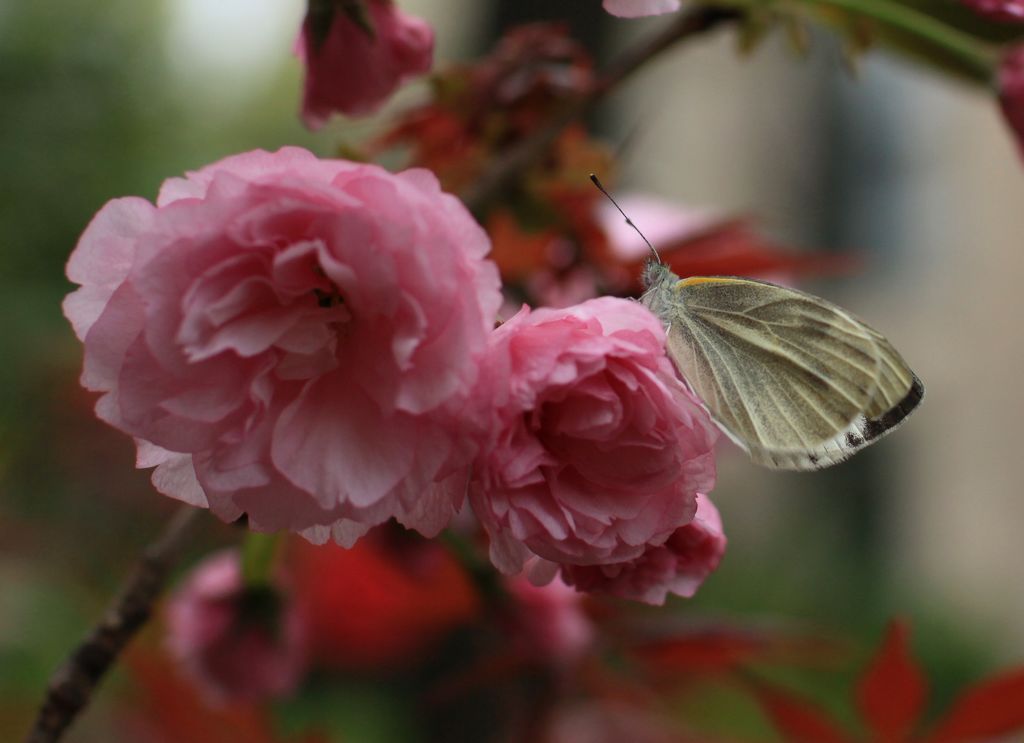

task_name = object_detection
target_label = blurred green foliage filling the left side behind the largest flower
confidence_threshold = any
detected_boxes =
[0,0,305,740]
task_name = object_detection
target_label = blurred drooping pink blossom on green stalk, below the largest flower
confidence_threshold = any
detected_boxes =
[167,550,307,702]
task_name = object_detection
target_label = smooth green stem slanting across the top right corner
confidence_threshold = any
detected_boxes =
[797,0,995,82]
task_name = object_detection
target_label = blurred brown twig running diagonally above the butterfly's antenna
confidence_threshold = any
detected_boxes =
[462,6,741,214]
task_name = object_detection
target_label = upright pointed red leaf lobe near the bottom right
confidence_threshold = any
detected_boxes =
[857,621,928,743]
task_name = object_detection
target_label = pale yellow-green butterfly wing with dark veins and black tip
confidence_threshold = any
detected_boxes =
[659,277,924,470]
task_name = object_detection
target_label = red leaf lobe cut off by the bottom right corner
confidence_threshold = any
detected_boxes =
[926,668,1024,743]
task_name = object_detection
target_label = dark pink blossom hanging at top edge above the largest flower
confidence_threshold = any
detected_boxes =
[295,0,434,129]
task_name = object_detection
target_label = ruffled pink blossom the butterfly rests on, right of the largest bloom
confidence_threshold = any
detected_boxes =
[471,297,717,573]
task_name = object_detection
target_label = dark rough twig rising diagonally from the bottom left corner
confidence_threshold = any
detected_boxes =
[26,506,203,743]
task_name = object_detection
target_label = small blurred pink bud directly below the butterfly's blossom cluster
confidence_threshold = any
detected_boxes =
[505,575,595,664]
